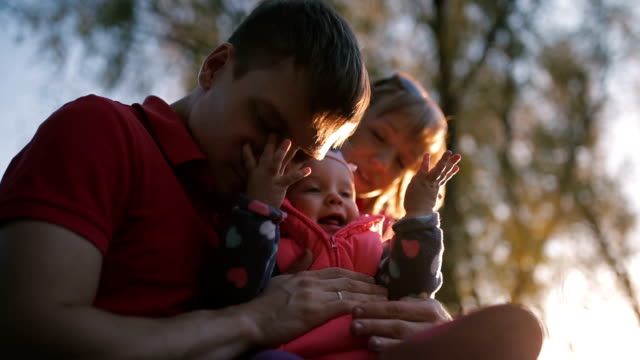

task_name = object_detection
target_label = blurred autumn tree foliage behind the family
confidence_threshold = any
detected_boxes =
[0,0,640,319]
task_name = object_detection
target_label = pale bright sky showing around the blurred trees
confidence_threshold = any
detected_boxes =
[0,11,640,360]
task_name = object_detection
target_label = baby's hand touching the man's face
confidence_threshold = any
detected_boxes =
[242,135,311,208]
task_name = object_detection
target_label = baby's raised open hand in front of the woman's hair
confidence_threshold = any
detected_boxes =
[404,151,462,216]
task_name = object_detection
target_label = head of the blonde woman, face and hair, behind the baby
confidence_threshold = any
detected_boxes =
[341,73,447,219]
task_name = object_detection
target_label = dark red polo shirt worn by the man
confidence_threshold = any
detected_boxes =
[0,95,218,316]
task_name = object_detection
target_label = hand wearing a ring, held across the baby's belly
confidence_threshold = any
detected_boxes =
[244,268,387,346]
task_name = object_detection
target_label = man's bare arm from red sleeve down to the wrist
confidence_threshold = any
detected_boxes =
[0,221,255,359]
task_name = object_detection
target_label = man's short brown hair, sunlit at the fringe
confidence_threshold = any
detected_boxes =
[228,0,371,153]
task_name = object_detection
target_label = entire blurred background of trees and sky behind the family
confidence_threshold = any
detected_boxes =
[0,0,640,360]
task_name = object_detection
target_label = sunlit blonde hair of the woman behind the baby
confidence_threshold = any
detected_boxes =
[363,73,447,219]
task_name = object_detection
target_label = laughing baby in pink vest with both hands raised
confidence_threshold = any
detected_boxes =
[210,138,460,359]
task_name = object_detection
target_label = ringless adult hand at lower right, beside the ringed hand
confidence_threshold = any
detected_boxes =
[351,298,451,351]
